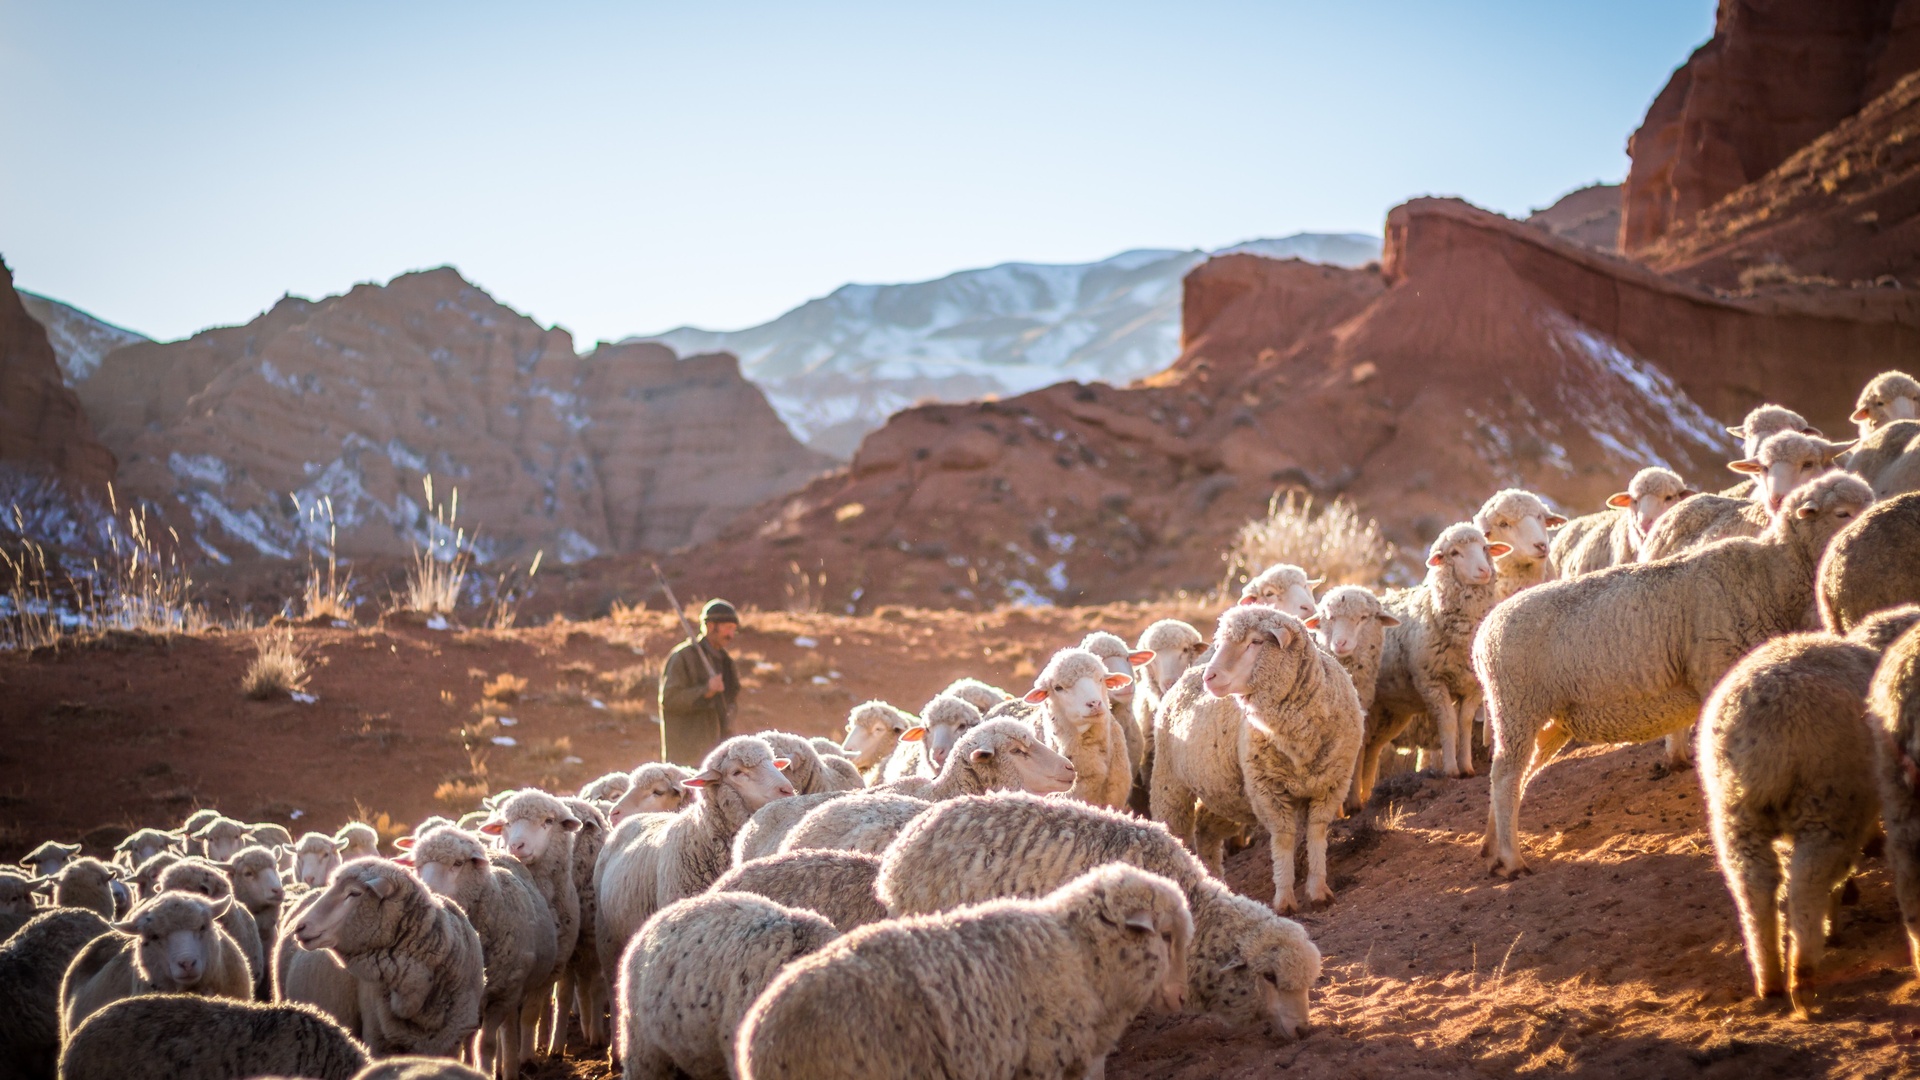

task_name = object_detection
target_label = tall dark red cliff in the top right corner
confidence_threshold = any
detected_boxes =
[1620,0,1920,252]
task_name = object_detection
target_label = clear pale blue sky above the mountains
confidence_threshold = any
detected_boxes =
[0,0,1715,350]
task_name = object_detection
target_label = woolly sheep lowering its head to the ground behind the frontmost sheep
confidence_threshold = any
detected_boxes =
[879,794,1321,1042]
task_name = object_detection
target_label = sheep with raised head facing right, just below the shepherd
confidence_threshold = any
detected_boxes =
[593,736,791,999]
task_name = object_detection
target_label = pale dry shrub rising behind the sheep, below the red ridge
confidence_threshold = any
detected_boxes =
[1221,490,1394,594]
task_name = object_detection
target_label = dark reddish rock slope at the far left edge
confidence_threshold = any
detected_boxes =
[0,261,113,494]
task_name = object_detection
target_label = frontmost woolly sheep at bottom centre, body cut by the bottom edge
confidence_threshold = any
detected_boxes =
[737,867,1192,1080]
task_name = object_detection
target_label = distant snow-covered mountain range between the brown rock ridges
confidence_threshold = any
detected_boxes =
[630,233,1380,459]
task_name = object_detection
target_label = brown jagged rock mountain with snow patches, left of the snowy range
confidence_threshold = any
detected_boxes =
[81,267,828,561]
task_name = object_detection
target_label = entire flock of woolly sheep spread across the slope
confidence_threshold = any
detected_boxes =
[11,373,1920,1080]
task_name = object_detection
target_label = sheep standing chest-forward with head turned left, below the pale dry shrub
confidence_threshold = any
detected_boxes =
[1152,607,1365,915]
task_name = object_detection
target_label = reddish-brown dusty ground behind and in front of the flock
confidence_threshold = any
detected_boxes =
[0,605,1920,1080]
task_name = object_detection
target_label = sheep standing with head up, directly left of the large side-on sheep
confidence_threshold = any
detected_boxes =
[1346,521,1509,799]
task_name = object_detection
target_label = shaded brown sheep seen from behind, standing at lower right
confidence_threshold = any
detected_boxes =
[1699,634,1880,1015]
